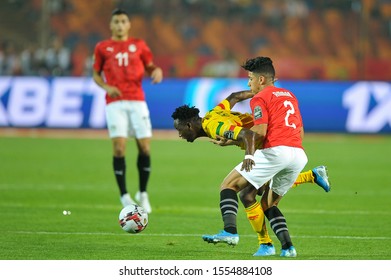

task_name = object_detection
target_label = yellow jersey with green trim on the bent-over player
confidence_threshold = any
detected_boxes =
[202,99,253,140]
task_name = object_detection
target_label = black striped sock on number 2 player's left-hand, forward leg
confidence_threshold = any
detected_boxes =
[220,189,239,234]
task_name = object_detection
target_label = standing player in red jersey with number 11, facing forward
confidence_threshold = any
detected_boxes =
[93,9,163,213]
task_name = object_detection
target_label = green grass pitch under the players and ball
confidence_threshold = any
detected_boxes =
[0,134,391,260]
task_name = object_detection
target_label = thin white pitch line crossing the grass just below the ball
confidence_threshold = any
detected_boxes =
[3,231,391,240]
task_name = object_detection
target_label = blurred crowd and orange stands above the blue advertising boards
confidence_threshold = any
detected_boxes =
[0,0,391,80]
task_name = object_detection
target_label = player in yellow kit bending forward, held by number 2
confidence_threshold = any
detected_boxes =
[171,91,330,256]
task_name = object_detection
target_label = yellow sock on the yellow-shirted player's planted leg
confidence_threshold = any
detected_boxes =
[245,201,273,244]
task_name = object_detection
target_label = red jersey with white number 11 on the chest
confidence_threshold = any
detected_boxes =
[93,38,153,103]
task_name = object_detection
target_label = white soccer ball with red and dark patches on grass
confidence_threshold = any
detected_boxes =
[118,204,148,233]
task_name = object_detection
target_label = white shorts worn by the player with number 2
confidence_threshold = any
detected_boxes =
[235,146,308,196]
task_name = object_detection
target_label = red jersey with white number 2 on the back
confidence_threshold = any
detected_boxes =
[250,86,303,148]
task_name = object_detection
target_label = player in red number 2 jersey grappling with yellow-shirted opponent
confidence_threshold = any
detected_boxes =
[203,57,308,257]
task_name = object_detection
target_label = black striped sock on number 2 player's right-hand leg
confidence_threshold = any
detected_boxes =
[265,206,293,249]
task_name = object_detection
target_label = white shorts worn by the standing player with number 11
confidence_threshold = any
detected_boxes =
[106,101,152,139]
